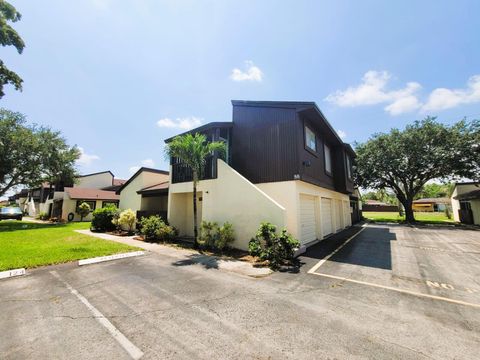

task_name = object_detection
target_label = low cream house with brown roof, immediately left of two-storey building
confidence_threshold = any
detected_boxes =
[116,167,169,220]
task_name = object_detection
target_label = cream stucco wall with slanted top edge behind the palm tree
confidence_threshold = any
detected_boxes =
[168,160,286,250]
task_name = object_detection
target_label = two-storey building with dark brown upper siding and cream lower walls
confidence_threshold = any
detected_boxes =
[166,101,359,249]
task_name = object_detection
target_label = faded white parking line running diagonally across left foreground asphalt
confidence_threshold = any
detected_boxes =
[50,271,143,359]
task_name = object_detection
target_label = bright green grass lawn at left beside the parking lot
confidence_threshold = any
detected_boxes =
[0,221,138,271]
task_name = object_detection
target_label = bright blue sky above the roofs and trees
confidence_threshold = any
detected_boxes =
[0,0,480,178]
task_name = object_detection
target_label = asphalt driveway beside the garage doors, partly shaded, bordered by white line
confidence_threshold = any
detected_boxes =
[305,225,480,311]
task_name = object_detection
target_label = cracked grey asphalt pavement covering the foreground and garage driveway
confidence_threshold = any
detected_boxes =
[0,227,480,359]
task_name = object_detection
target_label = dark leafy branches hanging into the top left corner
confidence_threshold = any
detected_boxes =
[0,0,25,98]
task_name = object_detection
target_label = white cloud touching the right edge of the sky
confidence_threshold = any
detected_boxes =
[422,75,480,111]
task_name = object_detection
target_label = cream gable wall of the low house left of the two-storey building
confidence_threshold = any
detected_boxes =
[119,171,169,211]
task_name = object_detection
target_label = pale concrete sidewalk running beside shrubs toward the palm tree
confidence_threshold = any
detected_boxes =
[75,230,272,278]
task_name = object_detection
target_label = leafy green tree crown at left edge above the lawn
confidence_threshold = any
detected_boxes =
[0,109,80,196]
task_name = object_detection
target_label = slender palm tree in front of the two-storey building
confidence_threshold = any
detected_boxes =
[165,133,226,248]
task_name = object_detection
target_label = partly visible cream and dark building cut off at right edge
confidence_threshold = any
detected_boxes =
[451,182,480,225]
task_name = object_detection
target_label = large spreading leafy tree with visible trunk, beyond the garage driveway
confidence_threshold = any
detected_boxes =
[355,117,480,222]
